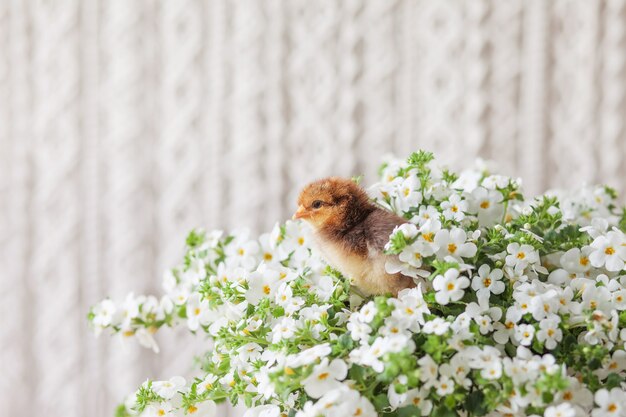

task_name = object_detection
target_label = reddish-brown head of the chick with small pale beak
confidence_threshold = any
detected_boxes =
[293,177,372,229]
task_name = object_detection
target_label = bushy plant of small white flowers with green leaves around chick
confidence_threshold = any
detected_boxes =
[89,152,626,417]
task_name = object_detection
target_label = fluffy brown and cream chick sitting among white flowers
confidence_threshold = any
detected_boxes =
[293,177,415,296]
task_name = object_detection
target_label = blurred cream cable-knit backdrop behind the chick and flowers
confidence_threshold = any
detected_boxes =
[0,0,626,417]
